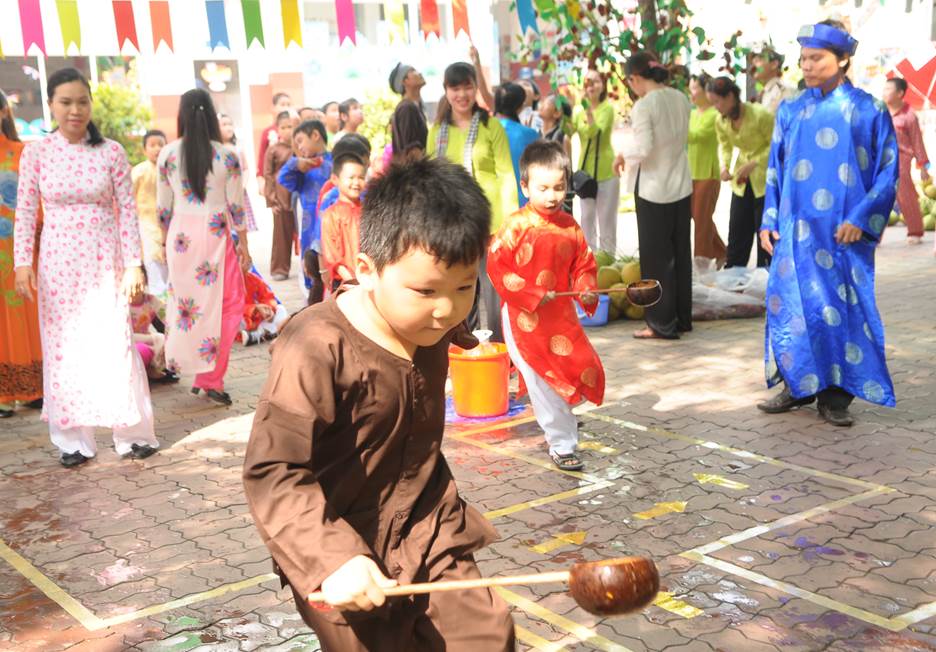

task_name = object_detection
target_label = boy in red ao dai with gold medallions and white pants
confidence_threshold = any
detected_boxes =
[488,140,605,471]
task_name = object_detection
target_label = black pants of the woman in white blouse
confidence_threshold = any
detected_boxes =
[636,190,692,337]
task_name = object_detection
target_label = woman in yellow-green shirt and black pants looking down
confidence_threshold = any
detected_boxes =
[705,77,774,267]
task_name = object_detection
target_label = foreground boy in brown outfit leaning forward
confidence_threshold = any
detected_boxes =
[244,159,515,652]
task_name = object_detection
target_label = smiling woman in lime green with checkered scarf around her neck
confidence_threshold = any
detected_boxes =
[426,62,519,342]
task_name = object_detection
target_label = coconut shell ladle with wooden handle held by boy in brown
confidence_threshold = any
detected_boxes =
[307,557,660,616]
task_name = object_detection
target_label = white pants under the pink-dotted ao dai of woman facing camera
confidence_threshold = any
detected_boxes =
[49,348,159,457]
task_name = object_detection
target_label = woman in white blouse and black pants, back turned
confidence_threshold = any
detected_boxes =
[615,52,692,339]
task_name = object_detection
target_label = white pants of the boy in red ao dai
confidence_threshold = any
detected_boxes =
[501,306,578,455]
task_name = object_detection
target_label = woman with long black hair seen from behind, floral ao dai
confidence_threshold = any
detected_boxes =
[156,88,250,405]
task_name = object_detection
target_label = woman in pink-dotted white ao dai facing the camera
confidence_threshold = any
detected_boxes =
[13,68,159,466]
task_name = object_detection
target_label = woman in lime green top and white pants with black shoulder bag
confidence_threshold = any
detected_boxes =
[573,70,621,253]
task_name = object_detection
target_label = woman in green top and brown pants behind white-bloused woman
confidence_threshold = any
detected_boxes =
[689,72,726,268]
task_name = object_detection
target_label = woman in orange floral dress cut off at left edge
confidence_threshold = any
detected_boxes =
[0,91,42,419]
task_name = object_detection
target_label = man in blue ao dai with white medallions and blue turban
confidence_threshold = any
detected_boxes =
[758,21,898,426]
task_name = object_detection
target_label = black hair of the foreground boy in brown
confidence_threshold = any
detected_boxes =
[361,158,491,272]
